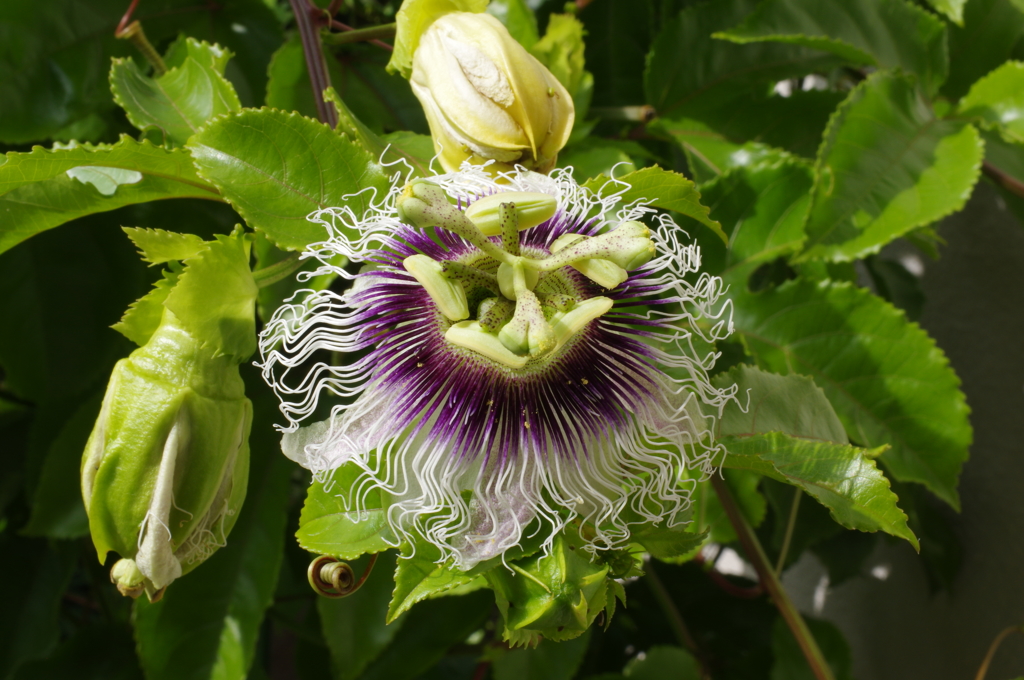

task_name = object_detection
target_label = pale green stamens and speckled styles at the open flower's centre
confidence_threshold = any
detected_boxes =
[398,180,654,369]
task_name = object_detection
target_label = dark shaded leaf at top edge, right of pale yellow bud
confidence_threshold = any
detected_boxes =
[644,0,837,122]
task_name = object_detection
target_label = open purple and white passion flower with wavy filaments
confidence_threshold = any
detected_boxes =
[260,164,732,570]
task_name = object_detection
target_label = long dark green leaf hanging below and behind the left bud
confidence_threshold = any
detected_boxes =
[133,385,290,680]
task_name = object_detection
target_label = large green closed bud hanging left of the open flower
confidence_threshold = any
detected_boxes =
[82,309,252,596]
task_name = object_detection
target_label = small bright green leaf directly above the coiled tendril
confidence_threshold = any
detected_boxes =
[295,465,393,559]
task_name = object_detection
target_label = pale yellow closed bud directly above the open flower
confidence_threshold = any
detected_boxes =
[410,12,574,172]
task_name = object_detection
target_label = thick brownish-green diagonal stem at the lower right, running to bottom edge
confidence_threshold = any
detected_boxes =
[711,475,836,680]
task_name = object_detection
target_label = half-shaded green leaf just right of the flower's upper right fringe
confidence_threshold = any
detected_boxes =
[700,160,813,287]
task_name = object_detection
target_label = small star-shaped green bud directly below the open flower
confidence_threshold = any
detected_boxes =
[486,536,608,643]
